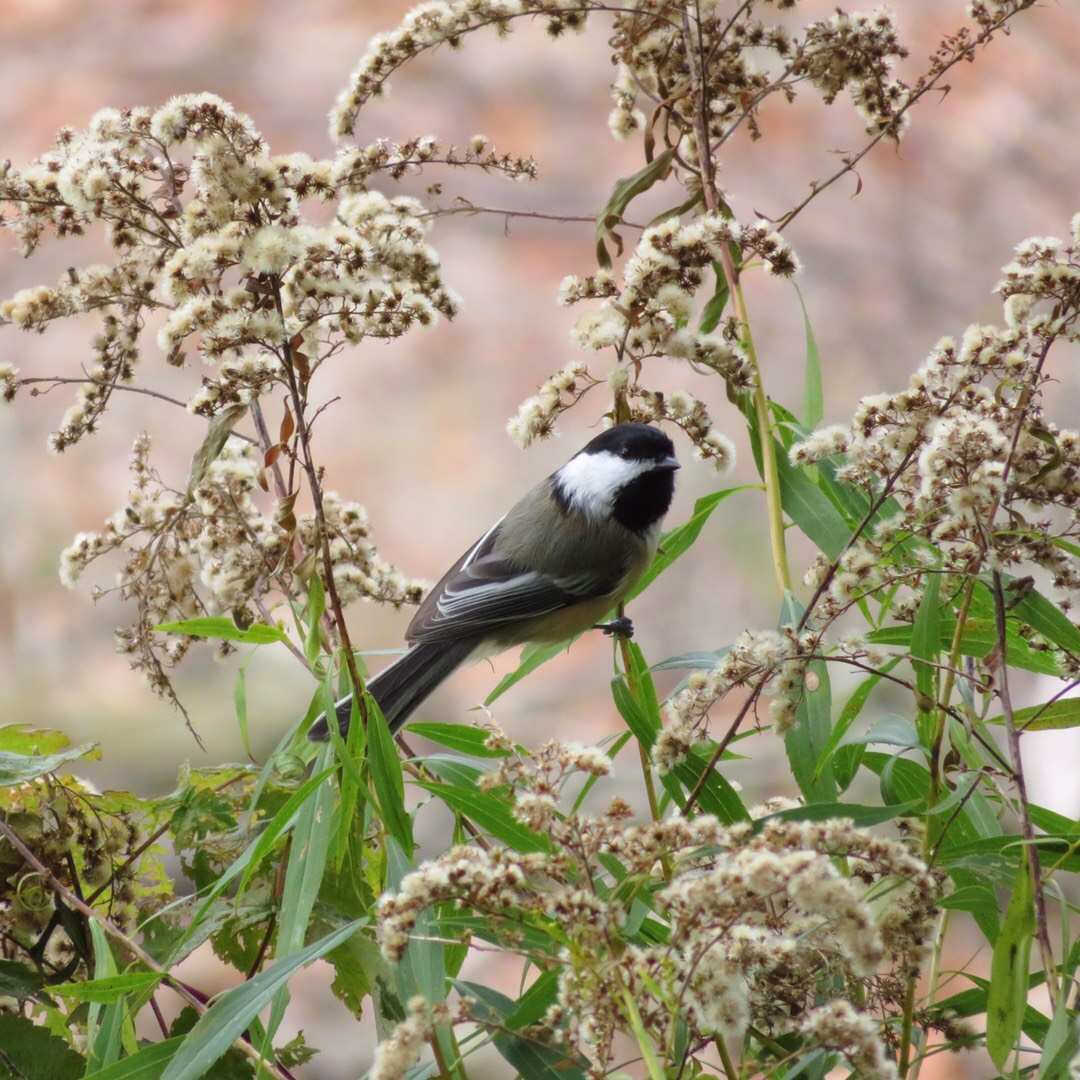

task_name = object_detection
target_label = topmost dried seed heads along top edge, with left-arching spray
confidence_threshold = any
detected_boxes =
[330,0,906,158]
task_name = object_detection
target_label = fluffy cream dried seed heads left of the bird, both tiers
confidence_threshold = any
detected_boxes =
[0,94,536,693]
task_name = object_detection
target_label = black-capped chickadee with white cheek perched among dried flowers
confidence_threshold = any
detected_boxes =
[310,423,679,740]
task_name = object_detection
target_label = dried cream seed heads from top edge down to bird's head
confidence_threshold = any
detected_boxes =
[341,0,1015,468]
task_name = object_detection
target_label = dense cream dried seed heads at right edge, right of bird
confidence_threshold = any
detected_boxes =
[792,218,1080,630]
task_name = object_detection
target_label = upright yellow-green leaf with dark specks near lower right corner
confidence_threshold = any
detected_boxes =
[986,858,1035,1069]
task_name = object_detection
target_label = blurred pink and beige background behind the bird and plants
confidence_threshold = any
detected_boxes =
[0,0,1080,1080]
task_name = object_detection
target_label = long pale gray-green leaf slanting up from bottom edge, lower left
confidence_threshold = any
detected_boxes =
[161,919,364,1080]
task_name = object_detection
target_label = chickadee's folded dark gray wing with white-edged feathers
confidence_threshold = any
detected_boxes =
[405,525,620,644]
